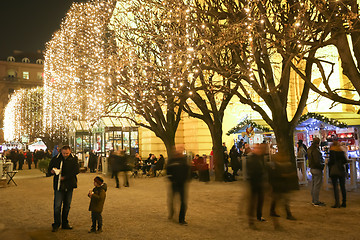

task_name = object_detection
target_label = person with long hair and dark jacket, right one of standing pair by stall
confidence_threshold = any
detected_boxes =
[328,141,347,208]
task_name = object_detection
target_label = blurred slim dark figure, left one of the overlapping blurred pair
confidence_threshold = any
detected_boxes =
[246,144,266,228]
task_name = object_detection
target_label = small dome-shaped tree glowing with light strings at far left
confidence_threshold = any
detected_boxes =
[4,87,44,142]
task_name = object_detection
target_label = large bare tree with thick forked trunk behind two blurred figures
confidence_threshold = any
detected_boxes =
[179,0,340,163]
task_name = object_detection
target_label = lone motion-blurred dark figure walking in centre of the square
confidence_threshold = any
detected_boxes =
[166,147,190,225]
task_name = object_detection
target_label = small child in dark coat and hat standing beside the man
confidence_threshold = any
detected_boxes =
[88,176,107,233]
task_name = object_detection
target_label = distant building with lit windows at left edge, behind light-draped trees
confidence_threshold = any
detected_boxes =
[0,51,44,143]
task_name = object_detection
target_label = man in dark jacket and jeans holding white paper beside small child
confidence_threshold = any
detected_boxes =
[48,146,79,232]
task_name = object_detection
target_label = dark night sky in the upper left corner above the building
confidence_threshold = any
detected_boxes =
[0,0,84,59]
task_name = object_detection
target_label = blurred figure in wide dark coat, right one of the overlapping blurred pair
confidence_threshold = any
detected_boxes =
[269,153,299,229]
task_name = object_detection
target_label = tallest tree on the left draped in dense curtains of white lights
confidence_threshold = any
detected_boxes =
[44,0,115,140]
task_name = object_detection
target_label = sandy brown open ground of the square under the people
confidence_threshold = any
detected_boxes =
[0,169,360,240]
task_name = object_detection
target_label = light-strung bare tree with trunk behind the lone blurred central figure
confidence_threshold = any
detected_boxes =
[110,1,187,156]
